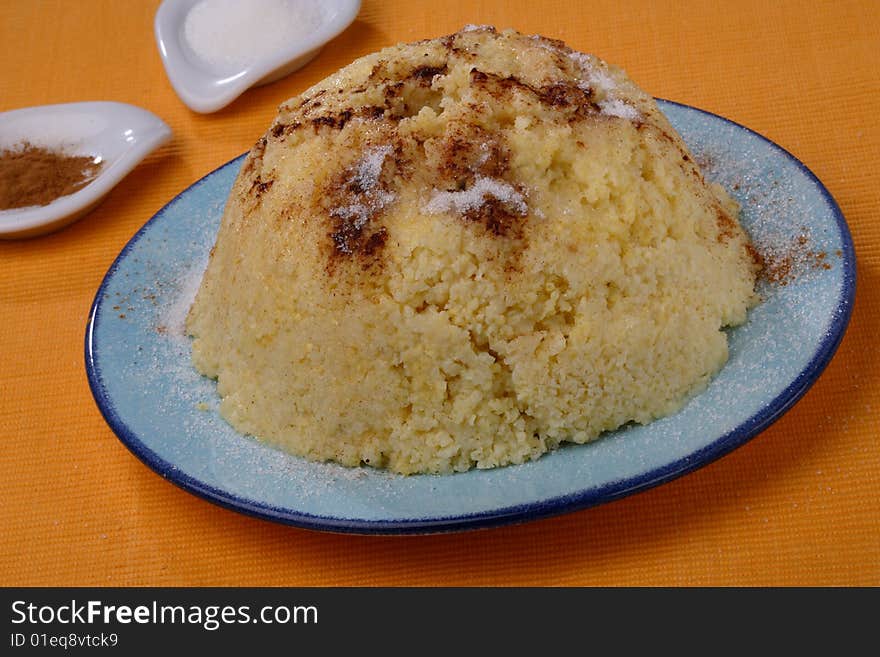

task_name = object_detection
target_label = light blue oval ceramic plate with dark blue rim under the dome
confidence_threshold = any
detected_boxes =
[85,101,855,534]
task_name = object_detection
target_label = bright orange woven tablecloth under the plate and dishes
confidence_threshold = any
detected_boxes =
[0,0,880,586]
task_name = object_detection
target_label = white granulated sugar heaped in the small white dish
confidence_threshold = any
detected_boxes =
[183,0,323,71]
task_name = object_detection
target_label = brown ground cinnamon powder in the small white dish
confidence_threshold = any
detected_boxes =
[0,142,103,210]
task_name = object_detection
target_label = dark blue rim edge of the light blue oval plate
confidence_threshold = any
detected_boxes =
[85,98,856,535]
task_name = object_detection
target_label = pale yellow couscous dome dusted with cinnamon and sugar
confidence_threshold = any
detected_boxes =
[187,26,757,474]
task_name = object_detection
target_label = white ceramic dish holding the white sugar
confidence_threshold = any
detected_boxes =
[154,0,361,113]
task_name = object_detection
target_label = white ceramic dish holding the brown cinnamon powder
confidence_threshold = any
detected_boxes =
[0,102,171,238]
